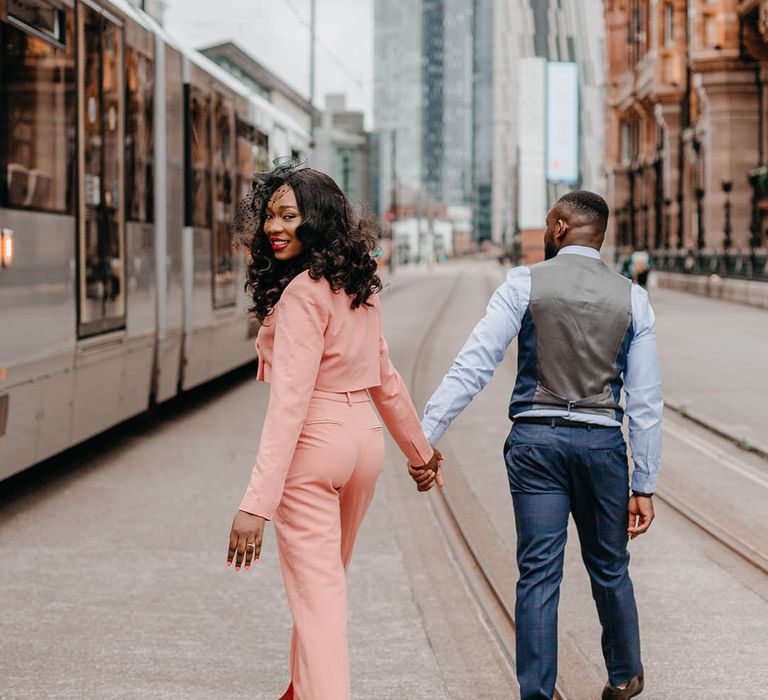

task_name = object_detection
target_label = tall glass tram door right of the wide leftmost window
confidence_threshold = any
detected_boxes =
[78,0,125,337]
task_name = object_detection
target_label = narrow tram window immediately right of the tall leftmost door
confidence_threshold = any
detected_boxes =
[125,48,155,223]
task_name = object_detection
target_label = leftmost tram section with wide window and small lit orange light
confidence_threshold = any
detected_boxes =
[0,8,76,478]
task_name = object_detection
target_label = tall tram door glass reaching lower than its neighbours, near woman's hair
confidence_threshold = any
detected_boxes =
[212,95,236,306]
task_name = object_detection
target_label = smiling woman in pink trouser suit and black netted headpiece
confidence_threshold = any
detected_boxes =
[227,165,441,700]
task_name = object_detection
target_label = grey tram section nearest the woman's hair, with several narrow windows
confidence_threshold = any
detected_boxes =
[182,59,254,389]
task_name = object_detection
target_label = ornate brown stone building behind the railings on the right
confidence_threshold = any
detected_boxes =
[605,0,768,274]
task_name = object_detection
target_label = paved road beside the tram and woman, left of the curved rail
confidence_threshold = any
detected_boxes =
[0,270,515,700]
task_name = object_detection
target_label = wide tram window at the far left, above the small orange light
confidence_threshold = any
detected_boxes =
[0,8,75,214]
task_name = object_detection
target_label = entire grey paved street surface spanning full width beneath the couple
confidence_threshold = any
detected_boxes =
[0,264,768,700]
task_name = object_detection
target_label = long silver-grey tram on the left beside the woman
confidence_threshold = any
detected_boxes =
[0,0,309,479]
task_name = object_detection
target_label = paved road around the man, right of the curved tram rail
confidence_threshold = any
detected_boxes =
[401,264,768,700]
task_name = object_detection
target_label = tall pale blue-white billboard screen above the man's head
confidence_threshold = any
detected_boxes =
[547,61,579,185]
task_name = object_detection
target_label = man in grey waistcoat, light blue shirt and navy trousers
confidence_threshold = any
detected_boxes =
[411,191,662,700]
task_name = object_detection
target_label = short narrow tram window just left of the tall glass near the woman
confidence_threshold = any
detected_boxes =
[189,86,211,228]
